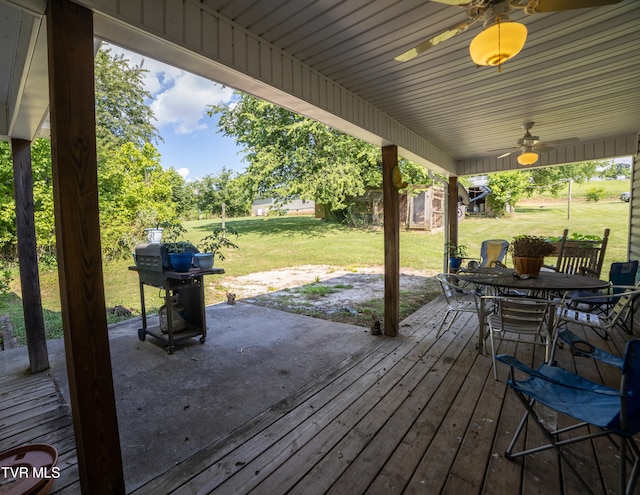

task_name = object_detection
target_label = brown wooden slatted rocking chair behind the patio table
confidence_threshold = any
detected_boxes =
[545,229,610,278]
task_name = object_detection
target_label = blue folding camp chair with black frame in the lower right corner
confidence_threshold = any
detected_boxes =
[497,337,640,495]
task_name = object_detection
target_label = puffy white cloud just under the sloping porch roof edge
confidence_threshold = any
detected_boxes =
[105,42,233,134]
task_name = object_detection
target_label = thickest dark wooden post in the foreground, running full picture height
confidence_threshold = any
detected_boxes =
[46,0,125,494]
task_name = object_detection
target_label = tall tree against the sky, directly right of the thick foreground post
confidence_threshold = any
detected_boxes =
[95,48,160,157]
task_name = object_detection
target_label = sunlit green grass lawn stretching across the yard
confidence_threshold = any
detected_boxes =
[0,194,629,343]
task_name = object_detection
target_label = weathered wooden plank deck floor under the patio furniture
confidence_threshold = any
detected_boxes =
[0,298,636,495]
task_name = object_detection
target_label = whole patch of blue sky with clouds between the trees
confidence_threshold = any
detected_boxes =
[103,44,247,180]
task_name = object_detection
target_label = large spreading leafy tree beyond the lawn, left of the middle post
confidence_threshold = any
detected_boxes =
[209,95,382,210]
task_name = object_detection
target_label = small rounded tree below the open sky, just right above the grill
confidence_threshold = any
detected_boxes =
[192,167,253,217]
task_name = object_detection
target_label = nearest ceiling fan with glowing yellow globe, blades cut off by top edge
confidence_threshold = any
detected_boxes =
[395,0,622,68]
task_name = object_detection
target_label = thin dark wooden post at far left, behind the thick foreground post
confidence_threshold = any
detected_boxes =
[11,139,49,373]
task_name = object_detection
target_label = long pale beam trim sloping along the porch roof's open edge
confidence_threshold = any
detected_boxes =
[82,0,456,175]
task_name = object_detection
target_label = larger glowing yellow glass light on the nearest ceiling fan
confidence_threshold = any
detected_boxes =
[469,2,527,72]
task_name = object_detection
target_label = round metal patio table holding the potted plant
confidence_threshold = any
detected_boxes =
[458,267,610,352]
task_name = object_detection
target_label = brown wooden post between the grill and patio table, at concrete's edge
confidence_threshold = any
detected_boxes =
[382,146,400,337]
